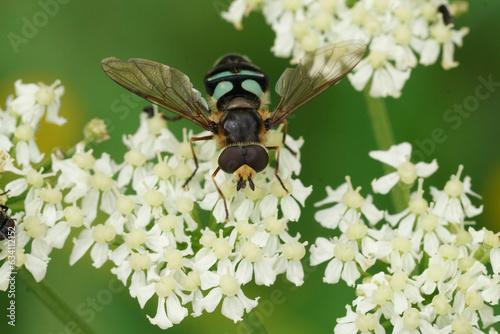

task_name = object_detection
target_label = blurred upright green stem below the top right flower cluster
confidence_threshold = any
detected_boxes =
[363,85,409,212]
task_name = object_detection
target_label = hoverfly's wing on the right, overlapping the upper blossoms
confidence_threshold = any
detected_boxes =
[266,40,366,129]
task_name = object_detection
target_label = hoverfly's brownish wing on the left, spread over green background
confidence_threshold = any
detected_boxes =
[101,57,216,132]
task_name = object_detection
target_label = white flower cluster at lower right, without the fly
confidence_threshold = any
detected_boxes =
[311,143,500,334]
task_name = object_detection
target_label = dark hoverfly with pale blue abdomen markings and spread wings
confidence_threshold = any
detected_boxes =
[102,40,366,221]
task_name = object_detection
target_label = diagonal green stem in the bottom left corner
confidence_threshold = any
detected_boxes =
[17,268,94,334]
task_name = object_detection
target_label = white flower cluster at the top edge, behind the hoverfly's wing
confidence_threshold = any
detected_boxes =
[222,0,469,97]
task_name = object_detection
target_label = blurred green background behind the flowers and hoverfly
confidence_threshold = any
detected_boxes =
[0,0,500,334]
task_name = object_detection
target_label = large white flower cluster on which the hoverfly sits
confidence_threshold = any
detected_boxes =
[0,81,311,329]
